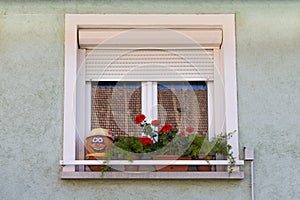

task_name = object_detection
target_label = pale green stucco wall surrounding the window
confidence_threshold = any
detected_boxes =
[0,0,300,200]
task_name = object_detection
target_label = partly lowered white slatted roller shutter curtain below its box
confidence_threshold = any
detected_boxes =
[85,49,214,81]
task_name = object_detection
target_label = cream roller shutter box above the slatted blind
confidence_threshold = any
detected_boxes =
[78,28,223,49]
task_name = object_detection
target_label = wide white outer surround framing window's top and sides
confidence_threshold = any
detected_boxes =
[61,14,243,178]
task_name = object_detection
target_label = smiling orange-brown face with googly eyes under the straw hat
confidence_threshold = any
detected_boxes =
[86,135,112,154]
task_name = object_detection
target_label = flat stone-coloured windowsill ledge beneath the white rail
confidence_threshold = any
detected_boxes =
[61,171,244,180]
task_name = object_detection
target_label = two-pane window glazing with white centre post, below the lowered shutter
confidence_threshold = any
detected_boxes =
[90,81,208,135]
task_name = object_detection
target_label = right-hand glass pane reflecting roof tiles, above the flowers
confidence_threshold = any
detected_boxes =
[158,81,208,134]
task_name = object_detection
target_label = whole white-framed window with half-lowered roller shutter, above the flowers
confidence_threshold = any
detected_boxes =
[61,14,242,177]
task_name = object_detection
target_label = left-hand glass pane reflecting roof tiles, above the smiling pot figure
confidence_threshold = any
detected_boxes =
[91,81,141,135]
